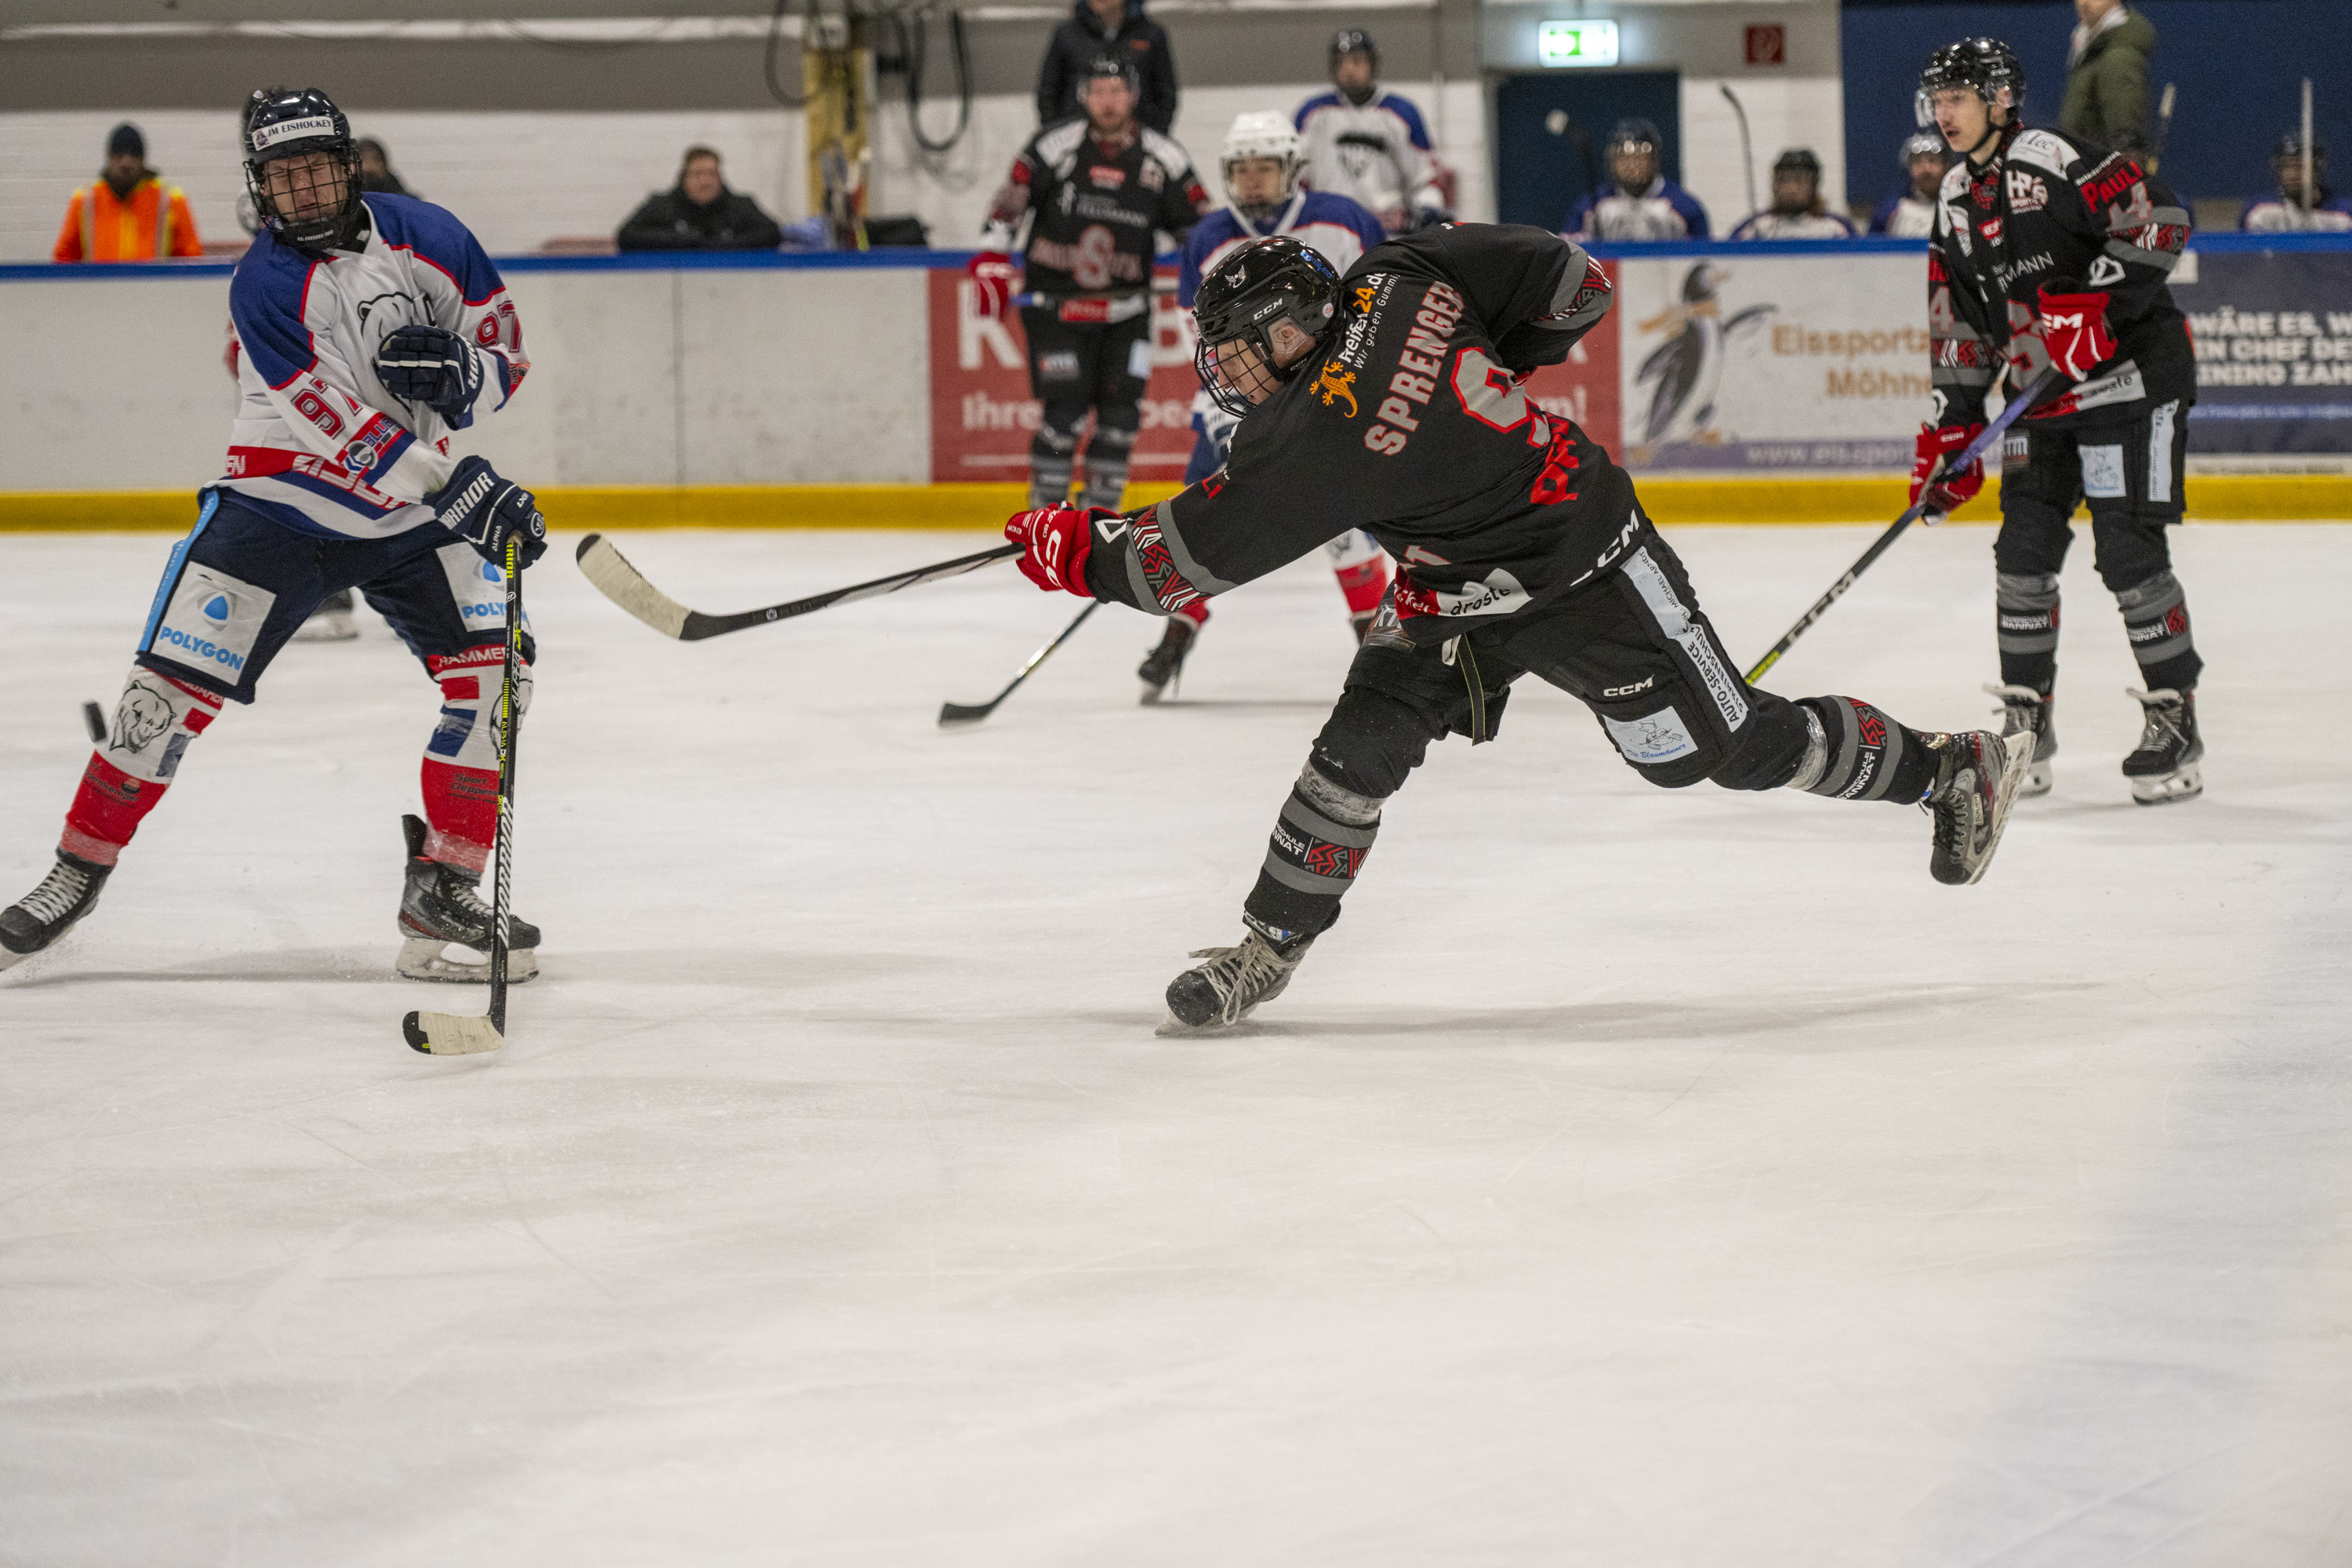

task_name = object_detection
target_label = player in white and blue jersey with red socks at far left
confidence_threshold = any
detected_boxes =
[0,87,546,980]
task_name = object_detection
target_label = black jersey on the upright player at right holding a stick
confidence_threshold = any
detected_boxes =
[1926,132,2197,426]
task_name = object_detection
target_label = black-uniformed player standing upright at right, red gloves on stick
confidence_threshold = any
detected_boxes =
[1912,38,2204,806]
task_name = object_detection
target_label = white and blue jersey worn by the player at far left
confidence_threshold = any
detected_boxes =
[221,193,532,539]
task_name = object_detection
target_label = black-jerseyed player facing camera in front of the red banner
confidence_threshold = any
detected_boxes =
[969,56,1211,508]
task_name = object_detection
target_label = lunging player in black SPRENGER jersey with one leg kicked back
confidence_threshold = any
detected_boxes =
[1004,226,2030,1029]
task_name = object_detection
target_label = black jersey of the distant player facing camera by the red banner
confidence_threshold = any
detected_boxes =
[981,120,1214,299]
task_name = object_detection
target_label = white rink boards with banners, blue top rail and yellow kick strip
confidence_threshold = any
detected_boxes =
[0,235,2352,529]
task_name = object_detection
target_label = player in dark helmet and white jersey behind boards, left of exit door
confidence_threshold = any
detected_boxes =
[1296,28,1454,235]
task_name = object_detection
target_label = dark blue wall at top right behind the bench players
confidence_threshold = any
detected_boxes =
[1839,0,2352,217]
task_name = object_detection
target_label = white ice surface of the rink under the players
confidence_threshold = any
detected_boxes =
[0,527,2352,1568]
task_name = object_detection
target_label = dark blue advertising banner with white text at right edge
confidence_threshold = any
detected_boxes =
[2173,252,2352,454]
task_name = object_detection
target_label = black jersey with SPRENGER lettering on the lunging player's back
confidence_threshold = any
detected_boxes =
[1087,223,1639,640]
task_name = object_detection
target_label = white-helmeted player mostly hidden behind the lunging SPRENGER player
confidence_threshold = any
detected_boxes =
[1136,111,1388,703]
